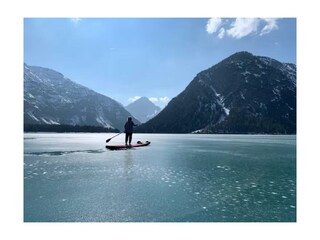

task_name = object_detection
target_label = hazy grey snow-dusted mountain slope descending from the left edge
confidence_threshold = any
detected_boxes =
[24,64,139,130]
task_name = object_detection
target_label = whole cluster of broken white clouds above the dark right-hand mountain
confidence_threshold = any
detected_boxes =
[206,18,279,39]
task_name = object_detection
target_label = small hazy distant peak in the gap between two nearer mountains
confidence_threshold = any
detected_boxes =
[126,97,161,123]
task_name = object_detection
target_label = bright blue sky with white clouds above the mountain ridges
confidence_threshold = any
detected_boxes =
[24,18,296,107]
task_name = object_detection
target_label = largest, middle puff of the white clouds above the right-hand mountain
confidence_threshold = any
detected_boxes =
[227,18,259,39]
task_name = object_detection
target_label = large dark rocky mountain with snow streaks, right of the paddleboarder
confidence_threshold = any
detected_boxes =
[137,52,296,133]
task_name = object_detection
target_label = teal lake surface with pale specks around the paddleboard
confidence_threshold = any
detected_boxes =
[24,133,297,222]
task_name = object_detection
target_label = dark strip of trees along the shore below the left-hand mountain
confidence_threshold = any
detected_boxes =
[24,124,120,133]
